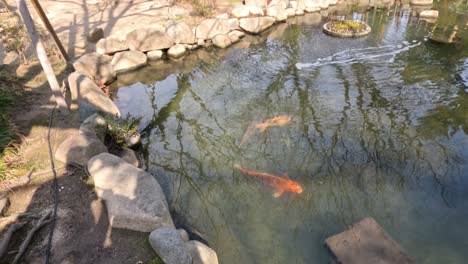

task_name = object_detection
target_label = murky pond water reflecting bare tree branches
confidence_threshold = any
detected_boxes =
[116,3,468,264]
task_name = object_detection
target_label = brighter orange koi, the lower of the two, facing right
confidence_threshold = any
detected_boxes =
[234,164,303,198]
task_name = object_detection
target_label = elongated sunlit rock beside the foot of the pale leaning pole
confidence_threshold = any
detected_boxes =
[66,72,120,116]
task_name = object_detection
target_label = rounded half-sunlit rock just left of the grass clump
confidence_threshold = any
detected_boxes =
[55,133,107,166]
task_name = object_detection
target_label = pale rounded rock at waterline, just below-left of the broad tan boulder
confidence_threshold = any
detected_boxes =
[111,50,148,74]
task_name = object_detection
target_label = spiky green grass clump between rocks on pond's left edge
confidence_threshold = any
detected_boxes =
[104,113,142,147]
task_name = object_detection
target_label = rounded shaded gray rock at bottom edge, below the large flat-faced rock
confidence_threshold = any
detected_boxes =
[149,227,192,264]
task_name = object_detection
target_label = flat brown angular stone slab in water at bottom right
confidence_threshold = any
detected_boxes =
[325,217,415,264]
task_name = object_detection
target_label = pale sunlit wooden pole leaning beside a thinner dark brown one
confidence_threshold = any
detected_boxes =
[16,0,69,114]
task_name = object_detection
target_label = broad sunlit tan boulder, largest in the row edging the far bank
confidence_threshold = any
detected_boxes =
[126,26,174,52]
